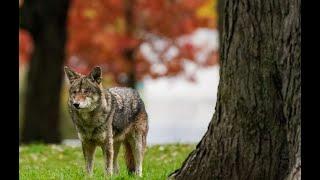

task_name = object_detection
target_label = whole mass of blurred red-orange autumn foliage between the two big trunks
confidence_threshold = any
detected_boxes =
[67,0,217,87]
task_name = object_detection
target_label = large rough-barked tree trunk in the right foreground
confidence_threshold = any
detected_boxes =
[170,0,301,180]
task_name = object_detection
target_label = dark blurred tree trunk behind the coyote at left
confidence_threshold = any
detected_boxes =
[20,0,69,143]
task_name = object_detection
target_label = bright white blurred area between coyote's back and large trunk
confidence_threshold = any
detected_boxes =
[143,66,219,144]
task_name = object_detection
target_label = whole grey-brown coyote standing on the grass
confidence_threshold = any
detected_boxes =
[65,67,148,176]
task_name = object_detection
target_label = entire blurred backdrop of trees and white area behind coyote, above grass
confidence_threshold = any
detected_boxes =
[19,0,219,144]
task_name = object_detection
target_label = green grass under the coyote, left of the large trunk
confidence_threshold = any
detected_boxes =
[19,144,195,180]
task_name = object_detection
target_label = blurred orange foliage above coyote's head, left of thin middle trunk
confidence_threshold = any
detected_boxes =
[66,0,138,84]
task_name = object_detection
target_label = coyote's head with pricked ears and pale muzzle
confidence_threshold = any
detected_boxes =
[64,66,103,111]
